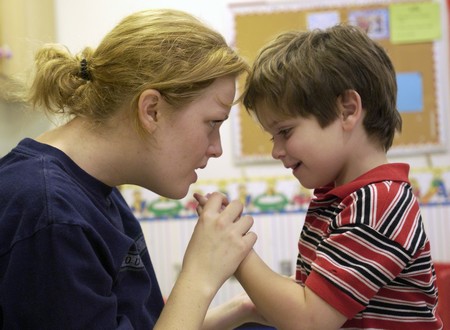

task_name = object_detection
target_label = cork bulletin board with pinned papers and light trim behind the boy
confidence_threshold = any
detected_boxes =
[231,0,449,163]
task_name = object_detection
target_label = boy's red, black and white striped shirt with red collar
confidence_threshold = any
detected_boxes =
[296,164,442,329]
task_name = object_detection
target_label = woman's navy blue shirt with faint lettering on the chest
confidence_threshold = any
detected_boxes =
[0,139,164,329]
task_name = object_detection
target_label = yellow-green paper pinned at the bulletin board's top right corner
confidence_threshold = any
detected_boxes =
[389,2,442,44]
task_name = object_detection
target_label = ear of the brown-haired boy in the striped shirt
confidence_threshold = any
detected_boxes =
[338,89,363,130]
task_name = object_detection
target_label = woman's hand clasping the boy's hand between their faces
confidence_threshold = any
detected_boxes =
[182,193,256,290]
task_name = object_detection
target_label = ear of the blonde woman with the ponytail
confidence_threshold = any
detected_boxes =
[138,89,162,132]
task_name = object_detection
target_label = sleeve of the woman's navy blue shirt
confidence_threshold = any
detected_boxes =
[1,224,132,329]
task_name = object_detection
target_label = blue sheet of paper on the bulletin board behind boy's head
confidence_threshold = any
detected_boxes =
[397,72,423,112]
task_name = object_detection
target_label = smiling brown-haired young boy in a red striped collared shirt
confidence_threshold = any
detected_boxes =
[235,25,442,329]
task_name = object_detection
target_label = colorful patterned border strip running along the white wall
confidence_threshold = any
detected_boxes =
[120,167,450,220]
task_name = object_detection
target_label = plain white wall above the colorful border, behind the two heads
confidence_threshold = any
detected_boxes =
[51,0,450,179]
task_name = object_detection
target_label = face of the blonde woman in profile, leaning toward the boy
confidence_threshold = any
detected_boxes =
[146,77,236,199]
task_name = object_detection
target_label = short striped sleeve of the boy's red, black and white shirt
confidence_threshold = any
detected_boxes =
[305,225,410,318]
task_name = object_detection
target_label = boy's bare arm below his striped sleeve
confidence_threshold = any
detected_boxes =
[235,250,347,330]
